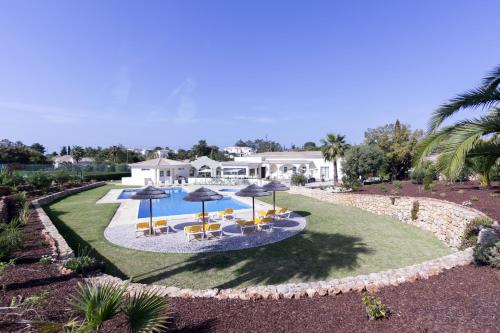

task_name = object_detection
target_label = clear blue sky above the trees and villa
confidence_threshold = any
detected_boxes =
[0,0,500,150]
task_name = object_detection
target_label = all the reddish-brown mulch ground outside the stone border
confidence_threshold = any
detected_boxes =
[0,183,500,332]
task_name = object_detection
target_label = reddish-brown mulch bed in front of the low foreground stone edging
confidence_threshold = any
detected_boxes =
[171,265,500,332]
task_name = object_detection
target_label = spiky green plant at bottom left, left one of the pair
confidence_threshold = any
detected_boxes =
[73,282,126,331]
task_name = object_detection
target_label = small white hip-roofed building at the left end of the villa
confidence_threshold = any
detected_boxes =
[122,158,191,186]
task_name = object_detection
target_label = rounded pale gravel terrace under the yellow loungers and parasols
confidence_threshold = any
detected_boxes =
[104,214,306,253]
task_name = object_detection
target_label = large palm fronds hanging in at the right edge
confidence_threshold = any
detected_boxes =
[415,65,500,185]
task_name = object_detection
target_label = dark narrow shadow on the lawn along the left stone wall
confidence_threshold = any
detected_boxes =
[43,206,128,279]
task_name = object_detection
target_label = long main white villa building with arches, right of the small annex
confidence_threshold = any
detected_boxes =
[191,151,343,181]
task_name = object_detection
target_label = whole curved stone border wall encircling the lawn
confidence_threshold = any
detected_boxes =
[42,185,485,300]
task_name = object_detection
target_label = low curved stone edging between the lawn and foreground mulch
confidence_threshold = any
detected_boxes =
[86,248,472,300]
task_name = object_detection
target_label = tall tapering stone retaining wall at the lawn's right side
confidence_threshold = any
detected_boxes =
[290,187,486,249]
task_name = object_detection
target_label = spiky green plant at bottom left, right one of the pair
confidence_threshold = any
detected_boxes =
[122,290,170,333]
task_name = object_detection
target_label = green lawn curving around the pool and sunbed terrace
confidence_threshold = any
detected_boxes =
[45,185,452,288]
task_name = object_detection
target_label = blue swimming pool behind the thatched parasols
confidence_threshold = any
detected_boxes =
[118,188,250,218]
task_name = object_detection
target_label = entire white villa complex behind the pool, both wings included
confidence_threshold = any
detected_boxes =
[122,151,343,186]
